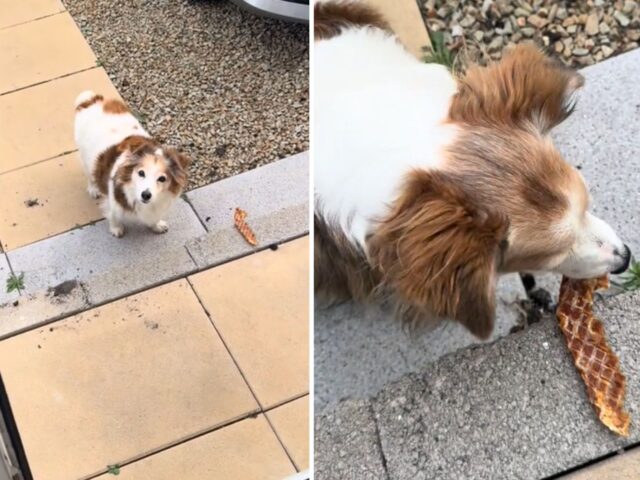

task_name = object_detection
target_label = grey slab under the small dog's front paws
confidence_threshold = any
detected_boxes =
[7,199,204,312]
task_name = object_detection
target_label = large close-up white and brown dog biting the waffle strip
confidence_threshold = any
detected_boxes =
[314,2,630,338]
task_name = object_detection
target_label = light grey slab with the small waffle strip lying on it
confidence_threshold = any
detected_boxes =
[187,152,309,267]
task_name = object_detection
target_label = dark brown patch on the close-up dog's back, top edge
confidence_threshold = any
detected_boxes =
[313,1,391,40]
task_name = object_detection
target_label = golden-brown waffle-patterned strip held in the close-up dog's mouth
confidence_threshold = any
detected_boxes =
[556,276,631,437]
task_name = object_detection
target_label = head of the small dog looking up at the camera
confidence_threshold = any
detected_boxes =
[114,137,189,206]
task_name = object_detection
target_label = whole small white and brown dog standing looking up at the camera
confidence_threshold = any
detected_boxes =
[75,91,189,237]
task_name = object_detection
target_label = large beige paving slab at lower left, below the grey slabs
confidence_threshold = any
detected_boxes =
[0,279,257,480]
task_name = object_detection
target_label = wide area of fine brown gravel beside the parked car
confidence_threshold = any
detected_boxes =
[64,0,309,189]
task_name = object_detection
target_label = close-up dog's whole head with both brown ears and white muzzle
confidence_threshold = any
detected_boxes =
[369,47,630,337]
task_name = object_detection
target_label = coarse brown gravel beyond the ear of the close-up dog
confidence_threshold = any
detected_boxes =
[418,0,640,68]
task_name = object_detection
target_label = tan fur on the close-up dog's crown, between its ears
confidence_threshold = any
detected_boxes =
[446,119,587,272]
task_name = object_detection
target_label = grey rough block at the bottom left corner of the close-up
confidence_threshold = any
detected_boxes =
[314,400,389,480]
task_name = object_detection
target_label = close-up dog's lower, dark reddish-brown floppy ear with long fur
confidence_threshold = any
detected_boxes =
[368,172,508,338]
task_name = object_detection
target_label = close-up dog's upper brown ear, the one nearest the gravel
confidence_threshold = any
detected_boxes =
[449,45,584,133]
